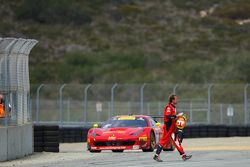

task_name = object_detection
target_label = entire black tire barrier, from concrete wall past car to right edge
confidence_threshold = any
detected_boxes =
[34,125,250,148]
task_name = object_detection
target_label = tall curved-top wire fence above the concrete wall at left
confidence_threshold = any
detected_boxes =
[0,38,37,125]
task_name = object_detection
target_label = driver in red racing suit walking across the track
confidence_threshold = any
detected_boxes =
[153,94,192,162]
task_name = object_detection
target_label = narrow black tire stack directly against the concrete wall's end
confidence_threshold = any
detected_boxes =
[34,126,44,152]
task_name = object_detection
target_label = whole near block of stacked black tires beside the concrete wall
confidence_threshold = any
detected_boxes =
[34,125,60,152]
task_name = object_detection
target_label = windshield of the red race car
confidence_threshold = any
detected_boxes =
[102,119,147,128]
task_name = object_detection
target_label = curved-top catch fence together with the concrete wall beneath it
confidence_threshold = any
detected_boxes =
[0,38,37,161]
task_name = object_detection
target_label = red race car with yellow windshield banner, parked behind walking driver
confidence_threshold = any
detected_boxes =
[87,115,174,152]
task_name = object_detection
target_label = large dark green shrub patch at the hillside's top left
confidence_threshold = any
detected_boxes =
[15,0,92,25]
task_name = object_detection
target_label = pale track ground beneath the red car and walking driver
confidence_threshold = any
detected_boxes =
[0,137,250,167]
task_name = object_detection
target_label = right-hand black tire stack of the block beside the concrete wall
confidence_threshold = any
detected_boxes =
[43,126,59,152]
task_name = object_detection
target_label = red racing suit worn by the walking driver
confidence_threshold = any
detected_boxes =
[159,103,184,155]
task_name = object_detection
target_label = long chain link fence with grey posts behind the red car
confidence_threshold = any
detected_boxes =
[30,83,250,125]
